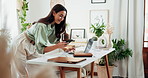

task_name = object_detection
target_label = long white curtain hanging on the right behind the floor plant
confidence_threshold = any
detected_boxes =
[113,0,144,78]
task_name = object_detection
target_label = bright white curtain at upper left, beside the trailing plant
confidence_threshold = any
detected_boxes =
[0,0,18,39]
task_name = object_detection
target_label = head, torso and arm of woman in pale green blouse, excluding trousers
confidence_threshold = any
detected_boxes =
[26,4,67,54]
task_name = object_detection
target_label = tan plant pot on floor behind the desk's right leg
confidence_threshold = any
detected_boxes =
[97,65,114,78]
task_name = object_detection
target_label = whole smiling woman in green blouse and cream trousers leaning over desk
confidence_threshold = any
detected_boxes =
[13,4,67,78]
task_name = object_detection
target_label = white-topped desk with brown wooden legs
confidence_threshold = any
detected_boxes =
[27,48,114,78]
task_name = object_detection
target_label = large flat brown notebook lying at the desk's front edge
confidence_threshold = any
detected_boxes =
[48,57,86,64]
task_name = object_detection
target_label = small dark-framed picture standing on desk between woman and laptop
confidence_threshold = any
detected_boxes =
[70,29,85,39]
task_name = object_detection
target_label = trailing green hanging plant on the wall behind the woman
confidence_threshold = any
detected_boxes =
[17,0,31,32]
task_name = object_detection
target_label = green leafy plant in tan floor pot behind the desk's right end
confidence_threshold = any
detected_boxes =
[97,39,132,78]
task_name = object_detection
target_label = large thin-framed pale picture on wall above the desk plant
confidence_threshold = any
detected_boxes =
[90,9,109,26]
